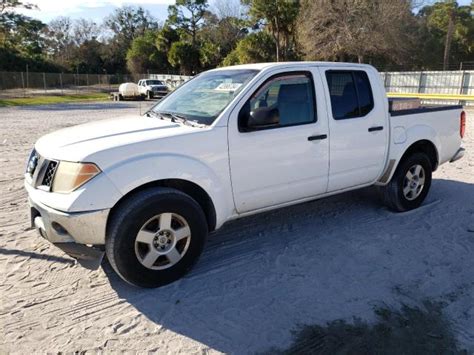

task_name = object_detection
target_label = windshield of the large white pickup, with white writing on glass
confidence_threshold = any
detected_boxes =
[152,69,258,125]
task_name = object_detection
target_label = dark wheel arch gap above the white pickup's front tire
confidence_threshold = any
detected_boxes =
[107,179,217,232]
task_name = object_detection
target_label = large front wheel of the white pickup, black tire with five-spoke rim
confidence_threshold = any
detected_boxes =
[105,188,208,288]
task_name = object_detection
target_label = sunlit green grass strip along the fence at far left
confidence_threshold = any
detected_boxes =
[0,92,109,107]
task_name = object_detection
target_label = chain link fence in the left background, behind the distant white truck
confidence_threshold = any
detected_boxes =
[0,72,190,98]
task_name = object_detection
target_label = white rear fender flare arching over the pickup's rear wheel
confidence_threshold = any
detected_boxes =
[377,124,440,185]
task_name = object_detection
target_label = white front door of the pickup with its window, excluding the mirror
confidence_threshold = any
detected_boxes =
[228,68,329,213]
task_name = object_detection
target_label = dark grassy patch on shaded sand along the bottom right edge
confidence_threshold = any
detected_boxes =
[268,302,467,355]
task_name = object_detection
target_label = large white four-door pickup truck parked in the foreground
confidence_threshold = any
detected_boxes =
[25,62,466,287]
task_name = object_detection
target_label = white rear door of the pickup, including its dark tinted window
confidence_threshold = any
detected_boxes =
[320,67,389,192]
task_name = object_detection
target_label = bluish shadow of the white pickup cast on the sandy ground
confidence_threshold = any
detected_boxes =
[104,180,474,353]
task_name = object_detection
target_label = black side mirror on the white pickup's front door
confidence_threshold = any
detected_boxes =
[239,104,280,132]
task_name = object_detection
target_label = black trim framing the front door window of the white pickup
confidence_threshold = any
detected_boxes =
[237,71,318,133]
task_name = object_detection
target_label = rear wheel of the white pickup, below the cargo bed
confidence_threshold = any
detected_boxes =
[381,153,433,212]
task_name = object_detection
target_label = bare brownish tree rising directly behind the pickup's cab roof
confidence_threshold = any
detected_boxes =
[298,0,414,63]
